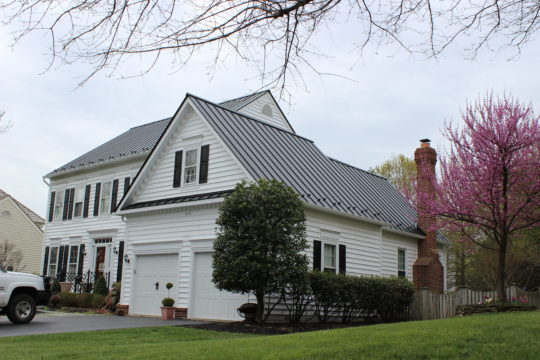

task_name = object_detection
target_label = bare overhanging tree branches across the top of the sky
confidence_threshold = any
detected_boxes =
[0,0,540,89]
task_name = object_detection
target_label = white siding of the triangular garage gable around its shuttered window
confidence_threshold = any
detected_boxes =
[129,111,248,203]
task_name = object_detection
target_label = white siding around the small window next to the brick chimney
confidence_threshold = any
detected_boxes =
[382,231,418,281]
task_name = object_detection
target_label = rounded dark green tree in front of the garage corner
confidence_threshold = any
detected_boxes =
[213,179,308,323]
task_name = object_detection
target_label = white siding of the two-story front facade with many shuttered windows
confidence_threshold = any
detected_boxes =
[41,161,142,284]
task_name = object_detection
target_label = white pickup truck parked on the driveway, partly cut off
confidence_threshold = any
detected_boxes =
[0,267,50,324]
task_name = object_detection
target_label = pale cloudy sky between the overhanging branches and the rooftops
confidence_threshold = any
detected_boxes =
[0,13,540,216]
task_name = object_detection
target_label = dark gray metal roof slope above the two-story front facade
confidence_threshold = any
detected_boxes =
[45,118,171,177]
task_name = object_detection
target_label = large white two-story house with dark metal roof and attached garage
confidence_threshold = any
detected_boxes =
[43,91,446,320]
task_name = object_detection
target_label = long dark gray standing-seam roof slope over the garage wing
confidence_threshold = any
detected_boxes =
[188,95,422,234]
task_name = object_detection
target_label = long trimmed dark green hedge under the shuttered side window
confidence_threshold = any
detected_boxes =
[310,271,414,323]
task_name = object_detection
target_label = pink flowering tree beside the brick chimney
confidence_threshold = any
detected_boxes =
[431,95,540,301]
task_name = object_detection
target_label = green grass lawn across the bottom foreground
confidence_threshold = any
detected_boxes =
[0,311,540,360]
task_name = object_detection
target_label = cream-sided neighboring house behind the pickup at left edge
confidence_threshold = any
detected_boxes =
[0,189,45,274]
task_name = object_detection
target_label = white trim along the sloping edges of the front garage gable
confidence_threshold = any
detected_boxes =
[116,94,253,215]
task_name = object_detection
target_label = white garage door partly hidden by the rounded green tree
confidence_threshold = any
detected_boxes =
[189,253,248,320]
